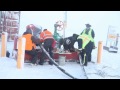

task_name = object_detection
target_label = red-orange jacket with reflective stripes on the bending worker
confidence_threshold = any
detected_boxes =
[40,30,53,42]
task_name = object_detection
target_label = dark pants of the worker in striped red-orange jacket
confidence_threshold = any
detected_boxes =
[40,39,54,64]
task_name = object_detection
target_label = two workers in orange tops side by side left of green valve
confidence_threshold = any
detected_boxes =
[23,25,54,65]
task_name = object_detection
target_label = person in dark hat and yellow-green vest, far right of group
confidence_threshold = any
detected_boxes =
[78,24,95,66]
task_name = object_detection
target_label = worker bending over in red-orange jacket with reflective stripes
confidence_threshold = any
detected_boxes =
[39,29,54,65]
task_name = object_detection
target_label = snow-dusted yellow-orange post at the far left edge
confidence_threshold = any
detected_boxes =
[1,32,7,57]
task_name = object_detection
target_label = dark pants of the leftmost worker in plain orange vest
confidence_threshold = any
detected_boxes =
[25,49,38,64]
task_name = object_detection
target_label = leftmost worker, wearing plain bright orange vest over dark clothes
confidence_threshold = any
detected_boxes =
[23,27,40,65]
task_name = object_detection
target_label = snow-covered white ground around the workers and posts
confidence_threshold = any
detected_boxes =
[0,42,120,79]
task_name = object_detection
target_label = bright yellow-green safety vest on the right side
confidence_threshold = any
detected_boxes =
[77,29,94,49]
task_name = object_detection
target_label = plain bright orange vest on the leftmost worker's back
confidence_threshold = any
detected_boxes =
[23,34,36,50]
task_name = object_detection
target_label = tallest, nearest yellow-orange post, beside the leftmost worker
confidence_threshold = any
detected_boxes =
[17,37,26,69]
